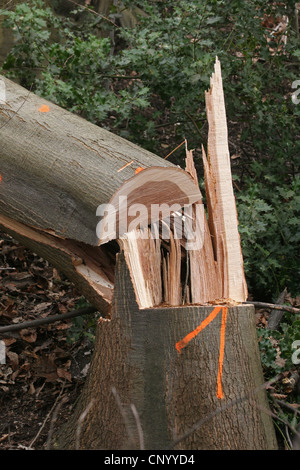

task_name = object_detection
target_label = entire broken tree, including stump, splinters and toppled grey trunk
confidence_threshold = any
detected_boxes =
[0,60,276,449]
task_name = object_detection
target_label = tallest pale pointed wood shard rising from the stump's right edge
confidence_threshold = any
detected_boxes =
[203,59,247,302]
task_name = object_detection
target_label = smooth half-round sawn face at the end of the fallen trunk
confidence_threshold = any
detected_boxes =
[98,167,201,245]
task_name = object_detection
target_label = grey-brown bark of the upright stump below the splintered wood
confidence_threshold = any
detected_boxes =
[53,254,276,450]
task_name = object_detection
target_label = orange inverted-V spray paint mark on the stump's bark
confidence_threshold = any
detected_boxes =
[175,306,227,399]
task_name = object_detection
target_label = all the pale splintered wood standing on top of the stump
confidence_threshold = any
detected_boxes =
[120,58,247,308]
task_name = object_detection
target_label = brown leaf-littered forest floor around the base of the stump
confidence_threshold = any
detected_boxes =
[0,233,297,450]
